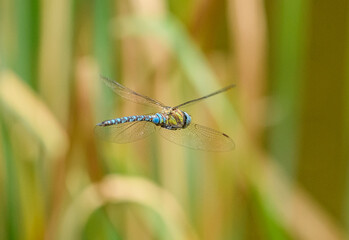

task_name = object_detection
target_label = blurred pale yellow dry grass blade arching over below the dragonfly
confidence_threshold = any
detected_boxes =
[60,175,197,239]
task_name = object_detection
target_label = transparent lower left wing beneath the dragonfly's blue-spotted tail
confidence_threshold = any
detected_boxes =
[95,121,156,143]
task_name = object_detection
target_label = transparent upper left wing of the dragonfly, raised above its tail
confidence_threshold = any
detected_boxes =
[101,76,166,109]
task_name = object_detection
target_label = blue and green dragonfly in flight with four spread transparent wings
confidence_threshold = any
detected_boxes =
[95,76,235,151]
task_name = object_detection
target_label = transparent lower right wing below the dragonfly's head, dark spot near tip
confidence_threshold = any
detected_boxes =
[159,123,234,152]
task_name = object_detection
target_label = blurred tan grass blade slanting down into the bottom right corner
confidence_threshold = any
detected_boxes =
[252,158,347,240]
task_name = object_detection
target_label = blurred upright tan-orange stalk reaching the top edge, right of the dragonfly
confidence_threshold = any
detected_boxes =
[227,0,266,143]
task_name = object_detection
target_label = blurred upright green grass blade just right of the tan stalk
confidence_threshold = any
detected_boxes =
[269,0,307,176]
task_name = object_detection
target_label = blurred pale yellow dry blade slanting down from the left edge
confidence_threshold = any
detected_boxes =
[0,72,69,159]
